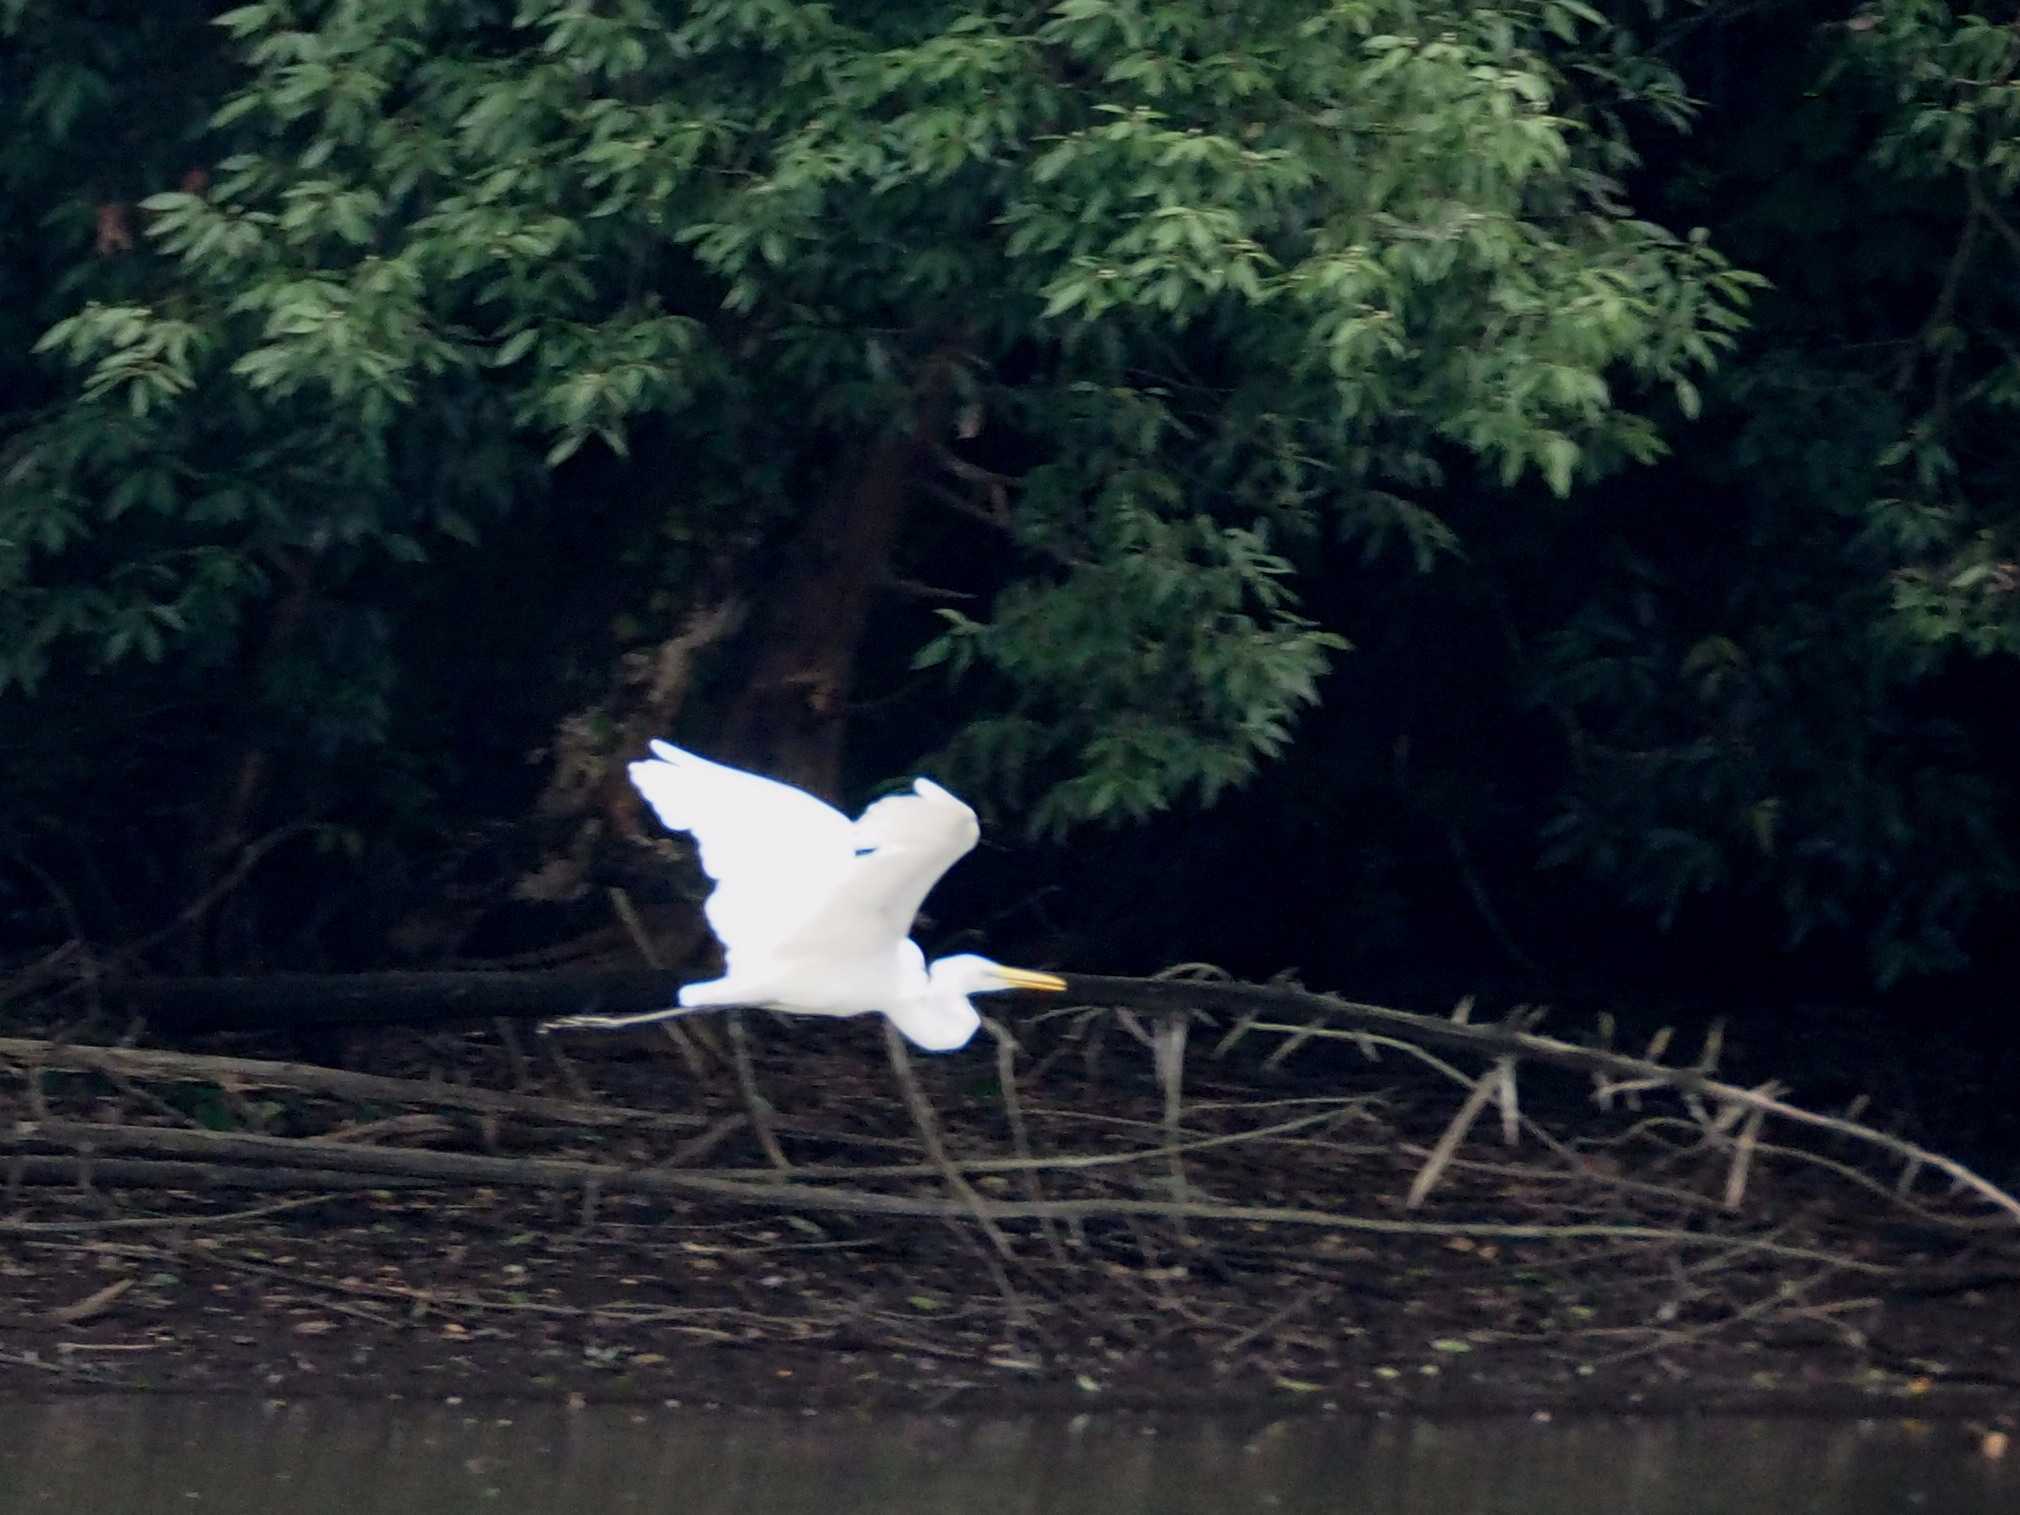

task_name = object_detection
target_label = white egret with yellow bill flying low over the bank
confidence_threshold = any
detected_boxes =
[549,741,1067,1052]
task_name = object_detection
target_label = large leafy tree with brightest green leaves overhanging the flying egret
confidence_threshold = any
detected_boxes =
[0,0,1751,961]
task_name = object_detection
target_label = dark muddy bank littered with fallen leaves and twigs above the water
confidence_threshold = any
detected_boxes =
[0,1016,2020,1428]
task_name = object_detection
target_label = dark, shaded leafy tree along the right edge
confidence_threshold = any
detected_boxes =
[1533,0,2020,984]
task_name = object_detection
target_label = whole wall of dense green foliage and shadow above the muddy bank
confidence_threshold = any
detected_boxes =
[0,0,2020,997]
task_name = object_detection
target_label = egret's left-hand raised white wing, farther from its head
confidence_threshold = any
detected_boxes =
[630,741,859,972]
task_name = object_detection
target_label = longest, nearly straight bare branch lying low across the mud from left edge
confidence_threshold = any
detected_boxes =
[0,1121,1901,1277]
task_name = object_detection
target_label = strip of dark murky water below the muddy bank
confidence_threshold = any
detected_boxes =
[0,1398,2020,1515]
